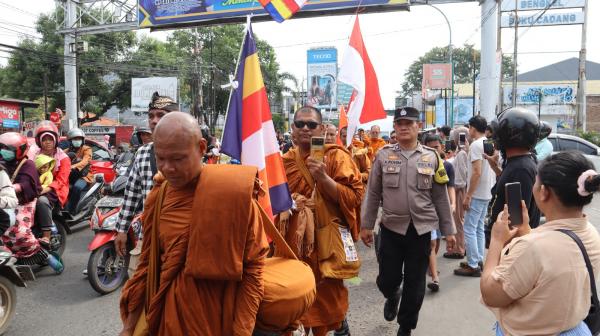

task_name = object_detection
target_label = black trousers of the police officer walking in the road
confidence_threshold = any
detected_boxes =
[377,223,431,329]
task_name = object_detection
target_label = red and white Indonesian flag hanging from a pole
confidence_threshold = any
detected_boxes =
[338,15,386,146]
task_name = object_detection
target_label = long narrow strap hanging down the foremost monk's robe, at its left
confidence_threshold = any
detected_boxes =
[145,181,168,311]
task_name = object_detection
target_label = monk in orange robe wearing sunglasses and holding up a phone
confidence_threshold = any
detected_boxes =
[279,107,364,336]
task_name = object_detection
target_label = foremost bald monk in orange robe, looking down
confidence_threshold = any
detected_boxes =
[120,112,268,336]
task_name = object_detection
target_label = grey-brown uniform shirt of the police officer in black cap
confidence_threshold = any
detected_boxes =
[361,144,456,235]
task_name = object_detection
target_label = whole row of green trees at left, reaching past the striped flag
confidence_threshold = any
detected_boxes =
[0,12,295,132]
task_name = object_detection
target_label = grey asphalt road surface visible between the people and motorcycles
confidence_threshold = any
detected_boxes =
[5,197,600,336]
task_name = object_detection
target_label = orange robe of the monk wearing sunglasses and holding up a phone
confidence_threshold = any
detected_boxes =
[283,145,364,336]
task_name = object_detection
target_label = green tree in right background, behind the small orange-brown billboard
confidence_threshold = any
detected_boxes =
[401,44,514,96]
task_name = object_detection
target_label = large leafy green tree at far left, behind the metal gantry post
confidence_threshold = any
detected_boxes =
[0,12,137,114]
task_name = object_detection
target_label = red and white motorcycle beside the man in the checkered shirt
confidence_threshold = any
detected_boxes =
[87,175,141,295]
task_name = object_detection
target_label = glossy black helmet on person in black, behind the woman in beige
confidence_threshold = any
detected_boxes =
[494,107,540,151]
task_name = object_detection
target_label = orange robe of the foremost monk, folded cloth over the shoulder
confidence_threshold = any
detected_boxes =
[121,171,268,336]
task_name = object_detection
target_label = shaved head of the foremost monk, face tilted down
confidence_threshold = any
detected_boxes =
[154,112,206,188]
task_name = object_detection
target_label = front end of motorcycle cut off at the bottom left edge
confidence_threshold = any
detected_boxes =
[0,250,35,335]
